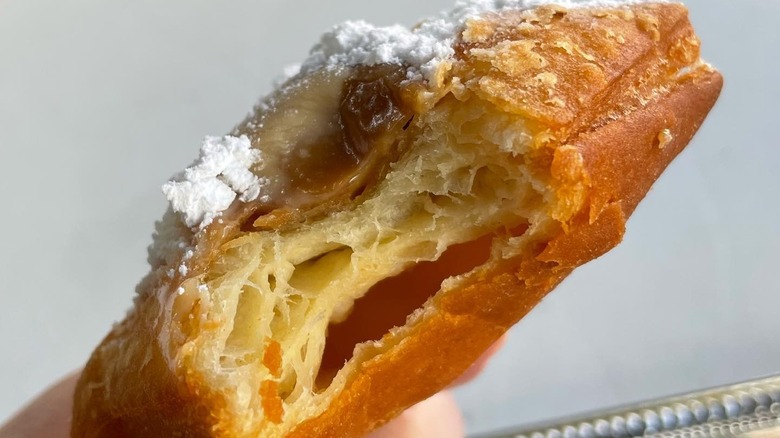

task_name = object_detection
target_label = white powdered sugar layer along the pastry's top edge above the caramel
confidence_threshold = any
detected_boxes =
[301,0,664,80]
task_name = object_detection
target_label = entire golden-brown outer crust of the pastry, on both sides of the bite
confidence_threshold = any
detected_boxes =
[72,4,722,438]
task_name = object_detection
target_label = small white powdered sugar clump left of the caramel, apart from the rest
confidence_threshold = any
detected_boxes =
[163,135,268,229]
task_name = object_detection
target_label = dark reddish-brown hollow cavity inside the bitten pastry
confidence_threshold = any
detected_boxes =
[316,234,494,389]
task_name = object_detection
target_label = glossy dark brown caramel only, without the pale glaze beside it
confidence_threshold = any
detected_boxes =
[243,65,414,231]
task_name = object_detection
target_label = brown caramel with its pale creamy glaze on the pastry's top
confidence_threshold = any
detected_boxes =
[188,65,415,286]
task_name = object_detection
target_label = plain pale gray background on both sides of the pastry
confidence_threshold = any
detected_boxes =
[0,0,780,431]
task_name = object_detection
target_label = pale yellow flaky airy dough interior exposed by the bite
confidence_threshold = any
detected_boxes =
[175,90,551,433]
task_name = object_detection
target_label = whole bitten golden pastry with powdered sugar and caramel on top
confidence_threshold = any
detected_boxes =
[72,0,722,438]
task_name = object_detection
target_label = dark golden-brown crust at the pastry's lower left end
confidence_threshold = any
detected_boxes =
[71,295,218,438]
